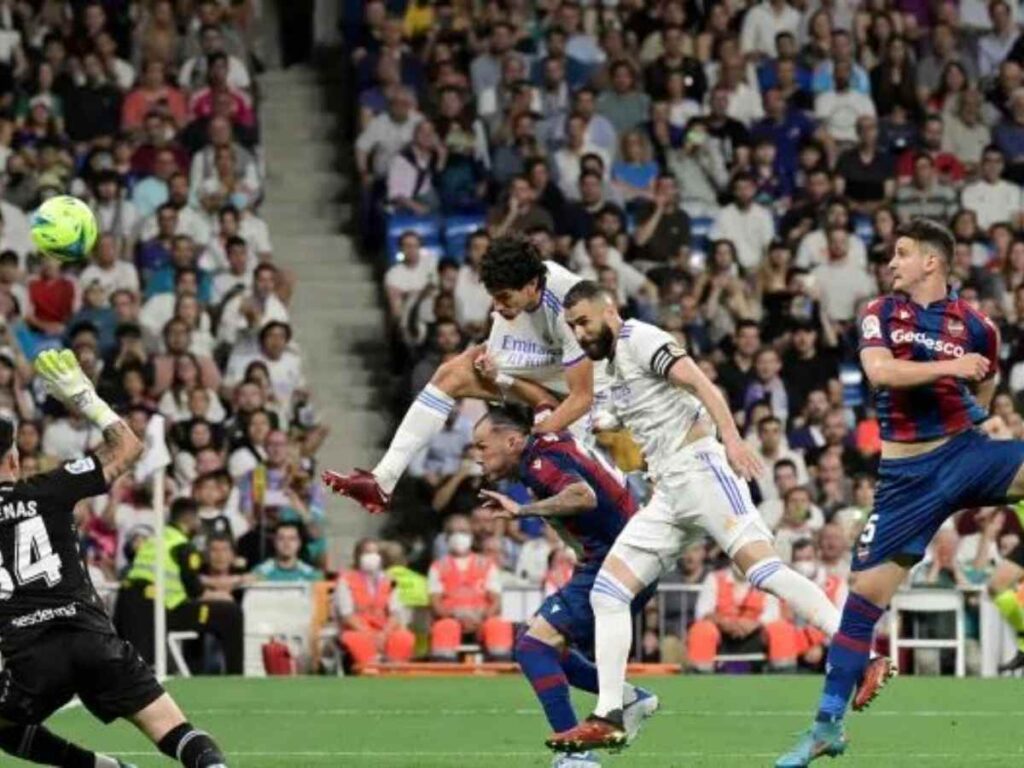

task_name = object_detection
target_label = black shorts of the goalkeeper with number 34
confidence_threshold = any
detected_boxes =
[0,627,164,725]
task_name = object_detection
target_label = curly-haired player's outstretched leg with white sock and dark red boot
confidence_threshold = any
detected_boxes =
[324,344,501,512]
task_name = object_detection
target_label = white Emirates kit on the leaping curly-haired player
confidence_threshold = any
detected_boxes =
[487,261,607,441]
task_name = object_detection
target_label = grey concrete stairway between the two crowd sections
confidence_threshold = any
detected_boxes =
[260,67,390,566]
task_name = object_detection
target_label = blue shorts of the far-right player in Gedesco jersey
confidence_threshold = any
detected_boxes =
[851,429,1024,570]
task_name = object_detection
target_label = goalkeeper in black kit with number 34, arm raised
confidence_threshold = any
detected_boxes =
[0,350,226,768]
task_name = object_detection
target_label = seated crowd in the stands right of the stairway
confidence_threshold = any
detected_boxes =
[345,0,1024,669]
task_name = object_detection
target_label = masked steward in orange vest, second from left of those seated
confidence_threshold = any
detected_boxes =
[428,515,512,658]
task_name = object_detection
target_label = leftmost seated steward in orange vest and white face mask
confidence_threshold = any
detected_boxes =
[334,539,416,668]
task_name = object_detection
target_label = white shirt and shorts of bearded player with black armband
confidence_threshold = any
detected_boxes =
[602,319,772,584]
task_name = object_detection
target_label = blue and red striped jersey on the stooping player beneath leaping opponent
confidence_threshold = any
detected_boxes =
[519,432,637,562]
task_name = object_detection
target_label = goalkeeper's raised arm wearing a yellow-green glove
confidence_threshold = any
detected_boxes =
[36,349,143,483]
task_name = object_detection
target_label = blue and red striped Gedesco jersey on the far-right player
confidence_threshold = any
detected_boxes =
[859,291,999,442]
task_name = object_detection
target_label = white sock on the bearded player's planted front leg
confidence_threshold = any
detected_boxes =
[590,570,633,717]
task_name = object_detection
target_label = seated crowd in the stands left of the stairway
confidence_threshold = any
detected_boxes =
[0,0,335,672]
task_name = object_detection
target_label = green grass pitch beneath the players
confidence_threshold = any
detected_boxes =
[14,676,1024,768]
